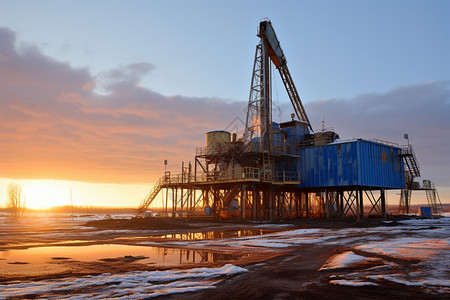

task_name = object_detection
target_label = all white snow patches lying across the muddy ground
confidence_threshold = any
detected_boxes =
[0,216,450,299]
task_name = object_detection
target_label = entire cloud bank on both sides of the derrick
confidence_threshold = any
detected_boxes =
[0,28,450,190]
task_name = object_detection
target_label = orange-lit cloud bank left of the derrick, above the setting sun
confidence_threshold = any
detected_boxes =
[0,28,246,183]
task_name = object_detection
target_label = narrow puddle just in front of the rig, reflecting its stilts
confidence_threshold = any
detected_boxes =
[160,229,274,241]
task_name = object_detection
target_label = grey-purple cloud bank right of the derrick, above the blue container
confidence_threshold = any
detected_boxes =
[302,81,450,186]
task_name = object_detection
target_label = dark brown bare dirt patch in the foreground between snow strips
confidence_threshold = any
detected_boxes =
[171,247,442,300]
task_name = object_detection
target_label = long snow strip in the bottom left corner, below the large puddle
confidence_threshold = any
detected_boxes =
[0,264,248,299]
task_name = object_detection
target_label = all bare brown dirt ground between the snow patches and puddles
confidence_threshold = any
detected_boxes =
[0,217,450,299]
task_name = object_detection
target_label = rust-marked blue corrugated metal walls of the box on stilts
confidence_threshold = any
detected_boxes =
[297,139,405,188]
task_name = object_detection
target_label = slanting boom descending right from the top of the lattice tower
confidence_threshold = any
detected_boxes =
[257,21,312,130]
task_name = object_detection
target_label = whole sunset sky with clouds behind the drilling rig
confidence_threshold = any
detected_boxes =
[0,0,450,207]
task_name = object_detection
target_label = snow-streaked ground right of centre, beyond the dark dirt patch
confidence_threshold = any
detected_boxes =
[137,217,450,293]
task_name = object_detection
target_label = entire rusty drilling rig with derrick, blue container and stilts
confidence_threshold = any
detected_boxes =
[136,20,442,220]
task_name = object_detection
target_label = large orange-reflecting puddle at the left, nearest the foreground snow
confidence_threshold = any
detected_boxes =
[0,244,242,274]
